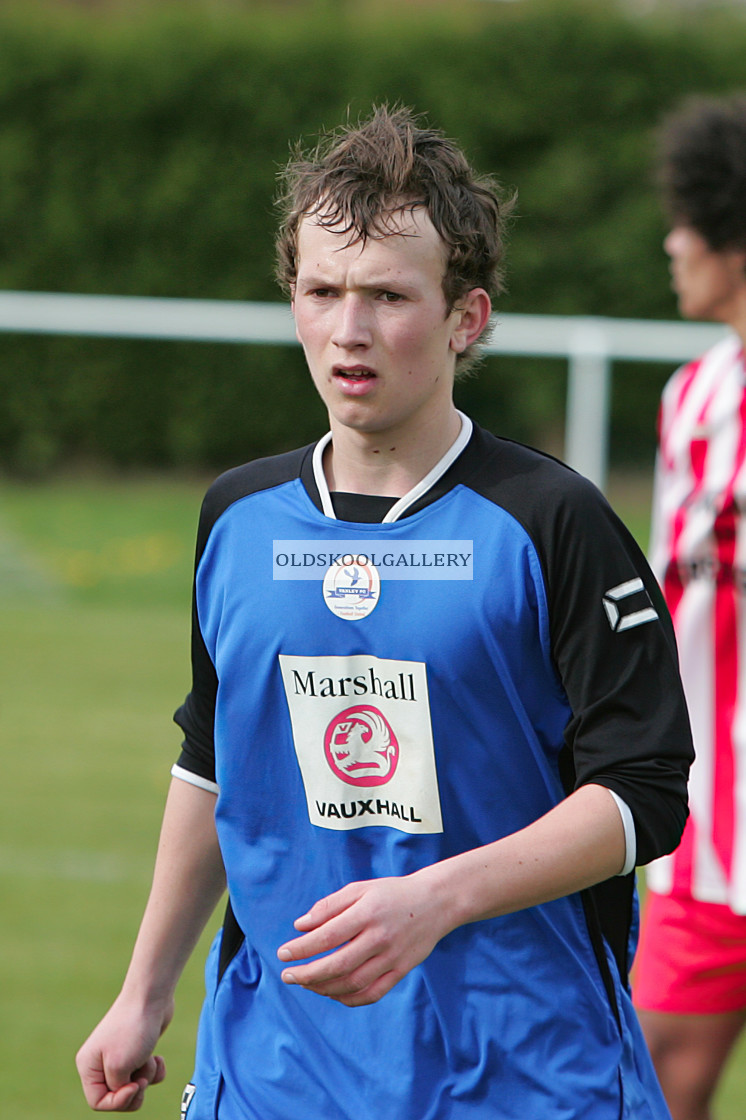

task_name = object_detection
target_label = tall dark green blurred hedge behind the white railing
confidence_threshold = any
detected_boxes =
[0,0,746,473]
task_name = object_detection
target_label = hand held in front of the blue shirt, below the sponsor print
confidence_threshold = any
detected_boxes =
[278,872,448,1007]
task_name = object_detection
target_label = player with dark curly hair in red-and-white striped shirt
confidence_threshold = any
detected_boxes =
[635,96,746,1120]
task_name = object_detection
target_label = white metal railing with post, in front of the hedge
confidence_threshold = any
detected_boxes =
[0,291,725,488]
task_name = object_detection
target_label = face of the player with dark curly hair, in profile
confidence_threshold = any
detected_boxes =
[663,225,746,323]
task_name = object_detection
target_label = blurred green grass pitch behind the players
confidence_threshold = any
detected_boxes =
[0,479,746,1120]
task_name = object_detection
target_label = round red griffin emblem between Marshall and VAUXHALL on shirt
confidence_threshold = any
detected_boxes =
[324,703,399,786]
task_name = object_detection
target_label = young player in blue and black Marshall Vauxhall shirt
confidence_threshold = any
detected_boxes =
[78,109,691,1120]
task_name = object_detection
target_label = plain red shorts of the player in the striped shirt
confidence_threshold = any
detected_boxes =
[632,890,746,1015]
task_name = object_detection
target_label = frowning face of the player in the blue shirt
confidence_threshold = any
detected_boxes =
[292,208,470,433]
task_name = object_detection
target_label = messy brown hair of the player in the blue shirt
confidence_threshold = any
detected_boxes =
[276,105,513,372]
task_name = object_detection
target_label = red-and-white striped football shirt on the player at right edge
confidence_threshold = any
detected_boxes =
[647,336,746,914]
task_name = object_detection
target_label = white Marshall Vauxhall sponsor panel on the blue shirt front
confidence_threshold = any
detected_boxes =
[280,654,442,833]
